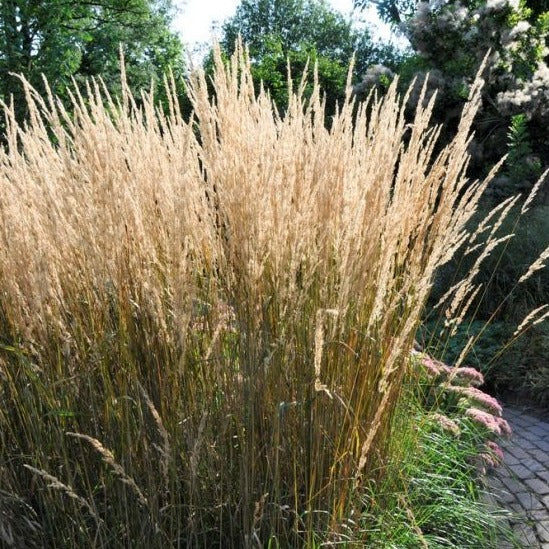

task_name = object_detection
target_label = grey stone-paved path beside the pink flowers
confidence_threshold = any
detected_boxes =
[489,406,549,549]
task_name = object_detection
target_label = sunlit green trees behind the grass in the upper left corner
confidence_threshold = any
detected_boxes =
[0,0,183,121]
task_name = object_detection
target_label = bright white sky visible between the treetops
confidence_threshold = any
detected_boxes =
[169,0,400,60]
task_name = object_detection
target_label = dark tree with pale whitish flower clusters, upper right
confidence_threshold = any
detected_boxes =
[355,0,549,193]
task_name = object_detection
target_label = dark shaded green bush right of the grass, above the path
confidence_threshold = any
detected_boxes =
[424,200,549,404]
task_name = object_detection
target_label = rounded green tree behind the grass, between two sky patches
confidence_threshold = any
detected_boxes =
[218,0,398,113]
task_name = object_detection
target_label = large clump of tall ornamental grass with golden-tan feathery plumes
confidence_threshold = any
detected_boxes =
[0,49,506,548]
